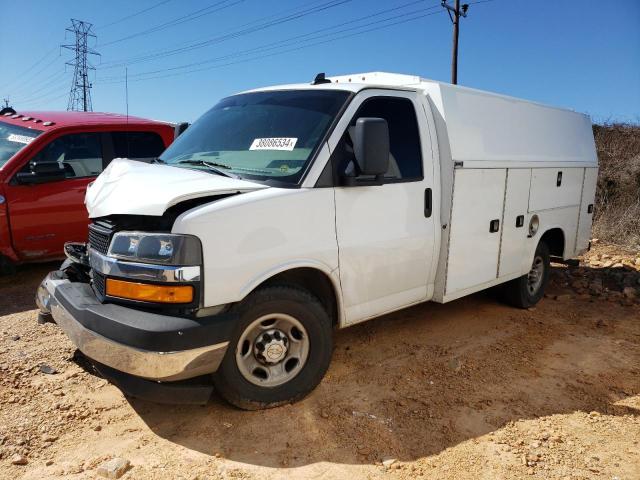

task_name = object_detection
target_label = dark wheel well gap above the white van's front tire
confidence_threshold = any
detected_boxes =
[258,267,338,325]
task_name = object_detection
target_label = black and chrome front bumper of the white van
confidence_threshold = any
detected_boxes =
[36,271,234,382]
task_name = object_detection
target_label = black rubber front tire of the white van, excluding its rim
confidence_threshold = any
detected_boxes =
[213,285,333,410]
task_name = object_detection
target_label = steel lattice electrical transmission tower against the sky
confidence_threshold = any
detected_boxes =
[61,18,100,112]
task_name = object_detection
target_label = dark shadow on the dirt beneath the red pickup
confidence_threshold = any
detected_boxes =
[0,260,60,316]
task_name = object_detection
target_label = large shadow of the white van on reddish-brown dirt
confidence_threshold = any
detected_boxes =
[129,267,640,467]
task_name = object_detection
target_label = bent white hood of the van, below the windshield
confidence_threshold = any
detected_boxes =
[85,158,268,218]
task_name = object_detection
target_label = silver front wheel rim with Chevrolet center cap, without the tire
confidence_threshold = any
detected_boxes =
[236,313,309,387]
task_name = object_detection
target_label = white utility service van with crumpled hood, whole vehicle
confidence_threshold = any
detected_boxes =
[37,72,598,409]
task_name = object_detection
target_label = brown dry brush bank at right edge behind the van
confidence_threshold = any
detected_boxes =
[593,123,640,248]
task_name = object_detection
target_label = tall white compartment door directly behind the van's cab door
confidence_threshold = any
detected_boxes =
[446,169,506,295]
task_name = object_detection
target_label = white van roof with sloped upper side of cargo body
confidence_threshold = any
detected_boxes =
[244,72,598,166]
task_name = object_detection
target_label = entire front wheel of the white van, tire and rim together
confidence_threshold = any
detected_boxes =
[213,286,333,410]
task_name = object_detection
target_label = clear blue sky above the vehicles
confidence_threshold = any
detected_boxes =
[0,0,640,122]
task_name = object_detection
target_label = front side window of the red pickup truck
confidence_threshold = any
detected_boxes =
[25,133,102,178]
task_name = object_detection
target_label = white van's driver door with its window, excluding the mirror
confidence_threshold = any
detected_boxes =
[331,89,434,323]
